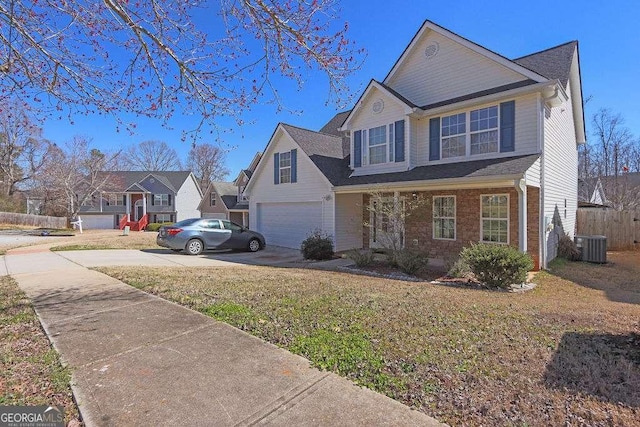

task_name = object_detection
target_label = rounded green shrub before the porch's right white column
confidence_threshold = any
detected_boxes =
[460,243,533,289]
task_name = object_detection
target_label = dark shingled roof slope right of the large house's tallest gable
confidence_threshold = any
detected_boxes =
[513,40,578,88]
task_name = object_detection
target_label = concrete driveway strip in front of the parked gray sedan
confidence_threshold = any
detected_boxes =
[56,246,352,268]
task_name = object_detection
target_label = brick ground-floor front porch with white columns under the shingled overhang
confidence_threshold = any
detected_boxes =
[336,181,542,269]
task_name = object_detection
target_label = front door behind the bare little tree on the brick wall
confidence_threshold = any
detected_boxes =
[369,197,405,250]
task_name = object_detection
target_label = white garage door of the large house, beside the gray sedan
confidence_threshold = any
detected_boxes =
[257,202,322,249]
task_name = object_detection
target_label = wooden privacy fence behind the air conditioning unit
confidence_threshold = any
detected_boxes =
[576,209,640,251]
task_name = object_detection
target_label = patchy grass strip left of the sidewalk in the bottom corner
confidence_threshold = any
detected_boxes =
[0,276,80,426]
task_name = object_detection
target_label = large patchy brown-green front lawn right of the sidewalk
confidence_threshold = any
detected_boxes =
[96,253,640,425]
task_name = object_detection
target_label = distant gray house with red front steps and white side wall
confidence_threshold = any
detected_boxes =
[79,171,202,230]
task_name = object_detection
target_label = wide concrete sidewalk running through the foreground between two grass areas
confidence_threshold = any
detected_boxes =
[4,252,440,426]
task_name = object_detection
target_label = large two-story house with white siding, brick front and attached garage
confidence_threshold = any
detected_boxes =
[245,21,585,267]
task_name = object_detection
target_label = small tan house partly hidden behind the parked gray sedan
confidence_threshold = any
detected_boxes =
[198,153,262,227]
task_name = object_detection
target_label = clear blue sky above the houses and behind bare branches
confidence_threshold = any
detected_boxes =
[44,0,640,179]
